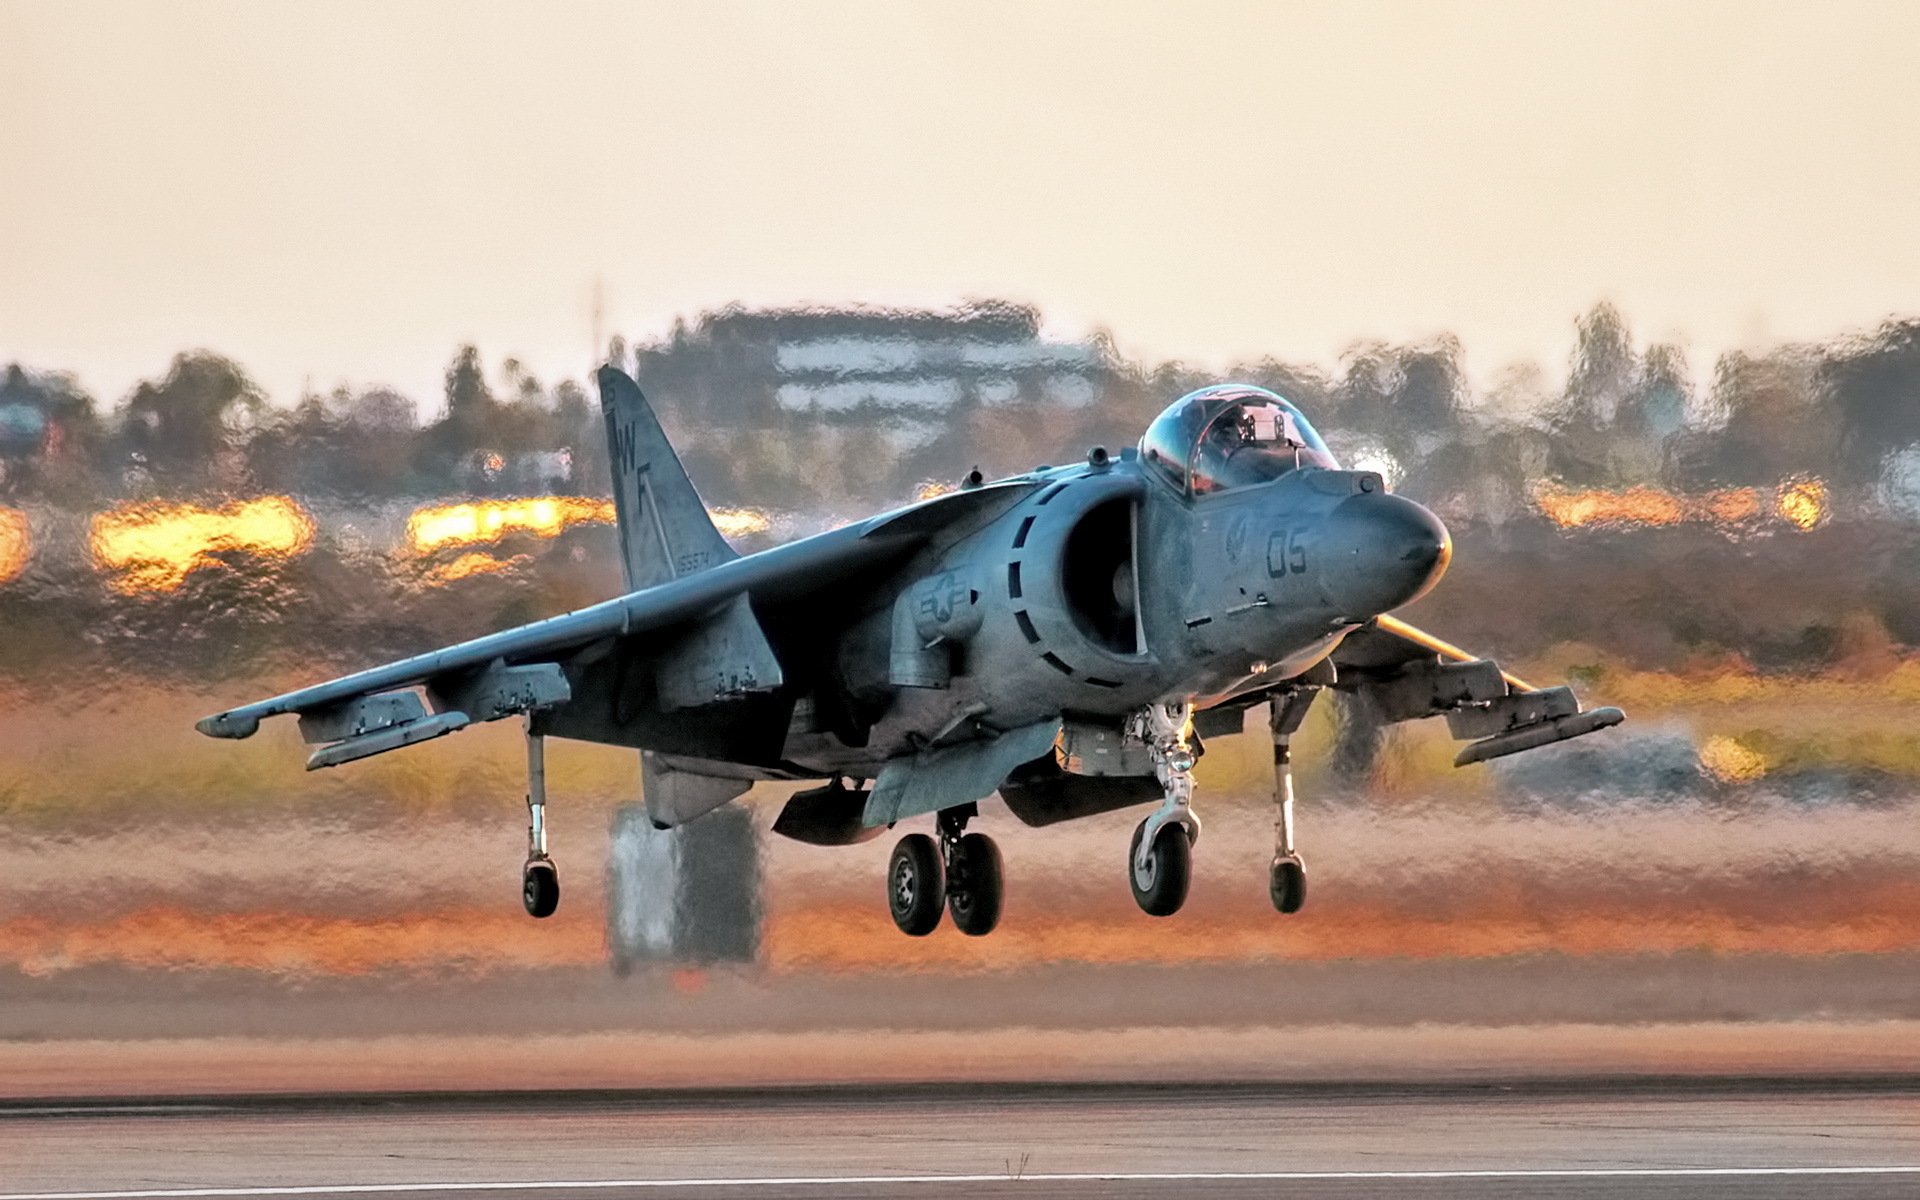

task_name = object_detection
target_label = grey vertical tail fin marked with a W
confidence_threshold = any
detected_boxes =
[599,367,739,591]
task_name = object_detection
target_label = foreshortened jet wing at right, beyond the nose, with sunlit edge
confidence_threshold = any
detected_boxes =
[1332,616,1626,766]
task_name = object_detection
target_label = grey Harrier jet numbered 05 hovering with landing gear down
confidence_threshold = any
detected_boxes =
[198,367,1622,935]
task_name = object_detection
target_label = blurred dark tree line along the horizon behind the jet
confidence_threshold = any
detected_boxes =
[11,305,1920,520]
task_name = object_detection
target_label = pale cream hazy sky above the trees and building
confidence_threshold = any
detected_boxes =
[0,0,1920,403]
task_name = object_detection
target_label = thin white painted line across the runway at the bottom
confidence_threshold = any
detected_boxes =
[0,1165,1920,1200]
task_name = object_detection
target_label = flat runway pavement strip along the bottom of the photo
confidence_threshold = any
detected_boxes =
[0,1079,1920,1200]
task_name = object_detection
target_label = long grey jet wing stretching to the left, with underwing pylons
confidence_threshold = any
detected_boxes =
[194,480,1033,770]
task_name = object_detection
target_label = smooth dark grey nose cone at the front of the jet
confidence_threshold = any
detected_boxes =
[1321,492,1453,620]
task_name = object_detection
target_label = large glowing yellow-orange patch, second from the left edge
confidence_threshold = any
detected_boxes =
[86,495,313,593]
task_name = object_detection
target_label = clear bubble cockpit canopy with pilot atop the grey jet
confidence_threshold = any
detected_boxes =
[1140,384,1338,495]
